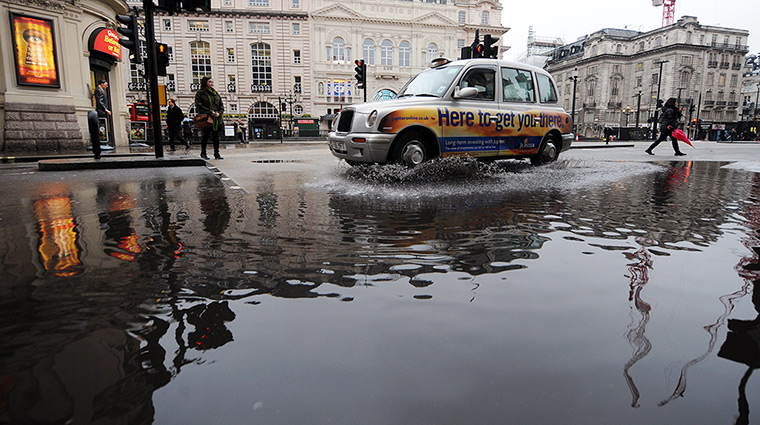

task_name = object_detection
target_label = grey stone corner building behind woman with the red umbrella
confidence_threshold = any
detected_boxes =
[547,16,749,137]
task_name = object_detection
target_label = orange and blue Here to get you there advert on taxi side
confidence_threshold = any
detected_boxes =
[378,106,571,157]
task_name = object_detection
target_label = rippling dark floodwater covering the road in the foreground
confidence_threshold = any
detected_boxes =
[0,160,760,424]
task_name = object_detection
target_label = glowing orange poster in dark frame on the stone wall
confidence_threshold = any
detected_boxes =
[10,12,61,87]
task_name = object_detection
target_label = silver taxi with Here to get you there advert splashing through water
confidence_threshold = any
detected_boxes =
[327,59,575,166]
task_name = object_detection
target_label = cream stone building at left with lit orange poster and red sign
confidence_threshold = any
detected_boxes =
[0,0,128,155]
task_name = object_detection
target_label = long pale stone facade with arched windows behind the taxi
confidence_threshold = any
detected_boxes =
[124,0,508,139]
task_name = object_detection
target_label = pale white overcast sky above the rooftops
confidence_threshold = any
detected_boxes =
[502,0,760,59]
